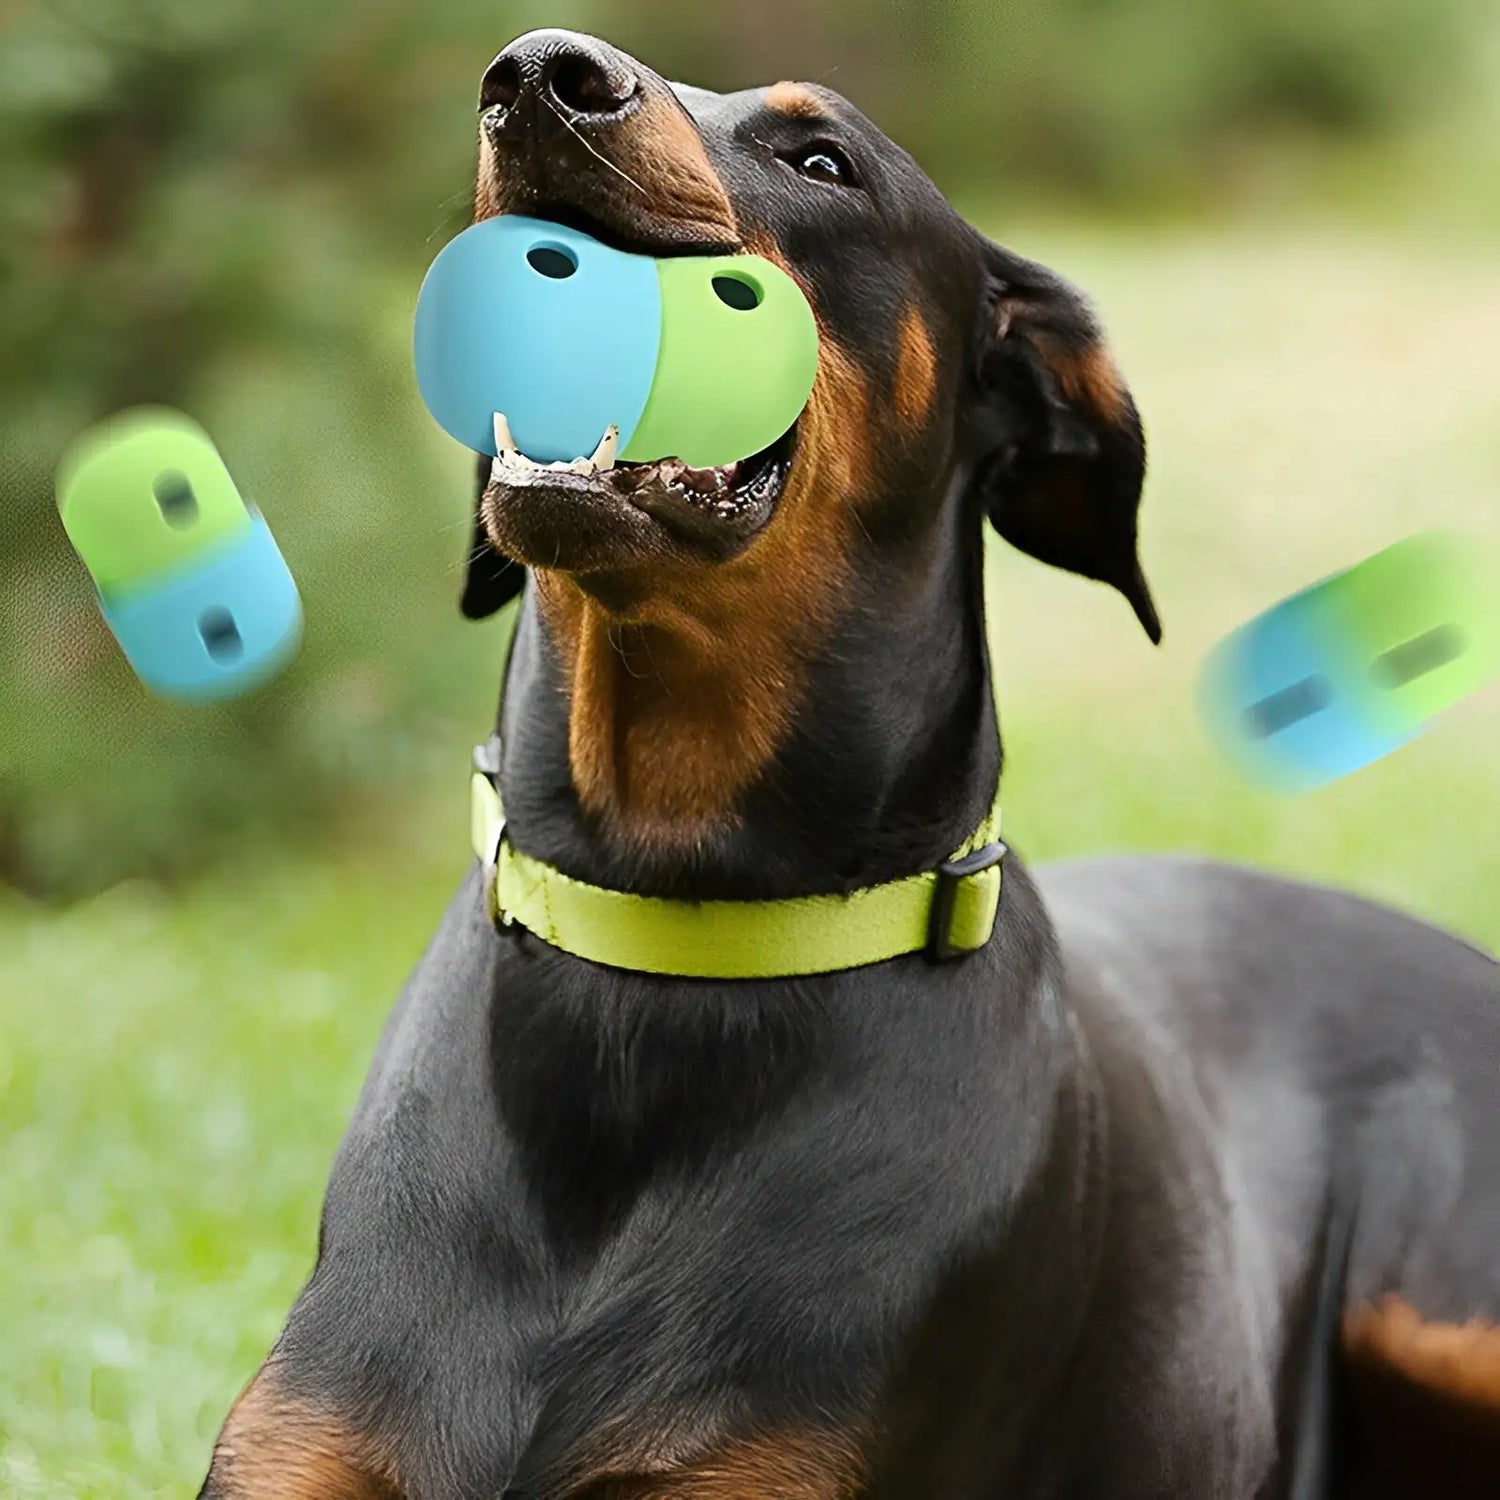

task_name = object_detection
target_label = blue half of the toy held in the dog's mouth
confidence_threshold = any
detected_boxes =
[413,215,662,462]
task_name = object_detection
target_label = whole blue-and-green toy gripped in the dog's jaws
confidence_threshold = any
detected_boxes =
[413,215,818,468]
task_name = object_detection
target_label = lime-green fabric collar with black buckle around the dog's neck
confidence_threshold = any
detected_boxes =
[471,528,1007,980]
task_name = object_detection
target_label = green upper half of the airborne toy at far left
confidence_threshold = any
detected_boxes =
[57,407,251,596]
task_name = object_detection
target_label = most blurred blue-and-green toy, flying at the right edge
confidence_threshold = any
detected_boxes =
[1199,533,1500,792]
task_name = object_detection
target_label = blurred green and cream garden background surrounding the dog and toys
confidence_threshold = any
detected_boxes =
[0,0,1500,1500]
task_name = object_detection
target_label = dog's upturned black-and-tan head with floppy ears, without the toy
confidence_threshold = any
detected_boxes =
[464,32,1160,639]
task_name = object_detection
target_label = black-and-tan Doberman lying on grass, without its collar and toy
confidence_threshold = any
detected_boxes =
[201,30,1500,1500]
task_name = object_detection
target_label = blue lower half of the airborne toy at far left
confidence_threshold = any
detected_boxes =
[99,515,302,702]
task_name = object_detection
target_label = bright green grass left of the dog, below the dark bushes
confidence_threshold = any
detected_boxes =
[0,852,464,1500]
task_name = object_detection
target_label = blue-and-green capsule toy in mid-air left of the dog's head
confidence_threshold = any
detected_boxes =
[57,408,302,701]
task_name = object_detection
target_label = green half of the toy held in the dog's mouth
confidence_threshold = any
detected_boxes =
[621,255,818,468]
